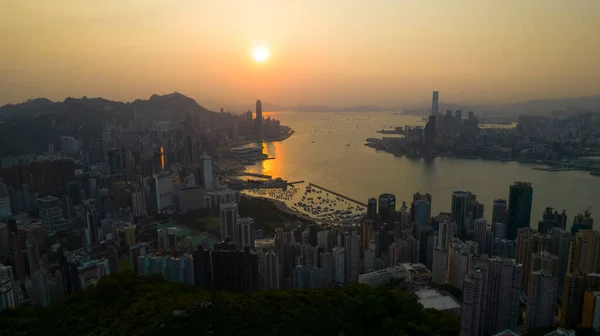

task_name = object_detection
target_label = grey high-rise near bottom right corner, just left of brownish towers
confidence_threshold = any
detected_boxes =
[525,271,558,332]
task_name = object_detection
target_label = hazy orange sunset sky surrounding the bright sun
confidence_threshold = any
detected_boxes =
[0,0,600,106]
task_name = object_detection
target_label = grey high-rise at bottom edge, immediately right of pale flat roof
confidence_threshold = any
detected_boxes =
[460,268,487,336]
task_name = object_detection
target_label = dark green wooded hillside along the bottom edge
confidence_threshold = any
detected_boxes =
[0,272,460,336]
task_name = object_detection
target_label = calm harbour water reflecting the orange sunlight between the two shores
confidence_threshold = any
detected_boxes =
[247,112,600,227]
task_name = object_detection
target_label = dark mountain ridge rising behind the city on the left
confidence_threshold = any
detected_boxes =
[0,93,216,157]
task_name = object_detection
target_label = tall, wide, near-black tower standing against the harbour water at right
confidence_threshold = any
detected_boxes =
[506,182,533,240]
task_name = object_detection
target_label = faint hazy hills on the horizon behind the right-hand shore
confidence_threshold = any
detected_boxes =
[404,95,600,116]
